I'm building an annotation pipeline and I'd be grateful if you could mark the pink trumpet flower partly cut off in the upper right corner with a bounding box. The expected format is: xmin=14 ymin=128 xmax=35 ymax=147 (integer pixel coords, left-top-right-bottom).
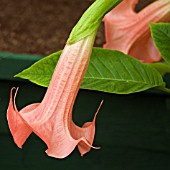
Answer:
xmin=104 ymin=0 xmax=170 ymax=62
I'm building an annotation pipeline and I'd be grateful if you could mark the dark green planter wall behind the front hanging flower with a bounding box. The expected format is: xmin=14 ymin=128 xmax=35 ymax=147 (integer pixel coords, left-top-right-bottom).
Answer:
xmin=0 ymin=54 xmax=170 ymax=170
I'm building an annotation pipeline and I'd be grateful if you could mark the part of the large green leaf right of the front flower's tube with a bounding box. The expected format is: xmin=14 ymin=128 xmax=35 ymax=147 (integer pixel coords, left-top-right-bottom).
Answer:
xmin=81 ymin=49 xmax=163 ymax=94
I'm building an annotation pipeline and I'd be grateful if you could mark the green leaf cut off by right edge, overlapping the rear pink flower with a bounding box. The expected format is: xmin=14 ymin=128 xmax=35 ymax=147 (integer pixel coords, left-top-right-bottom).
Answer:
xmin=150 ymin=23 xmax=170 ymax=64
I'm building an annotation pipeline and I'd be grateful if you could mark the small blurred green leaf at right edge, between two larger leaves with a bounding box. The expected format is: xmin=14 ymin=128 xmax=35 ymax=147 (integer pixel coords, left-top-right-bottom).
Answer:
xmin=149 ymin=62 xmax=170 ymax=76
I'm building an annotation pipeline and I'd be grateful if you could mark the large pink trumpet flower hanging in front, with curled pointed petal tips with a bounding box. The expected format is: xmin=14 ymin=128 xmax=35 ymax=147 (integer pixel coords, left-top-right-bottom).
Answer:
xmin=7 ymin=34 xmax=101 ymax=158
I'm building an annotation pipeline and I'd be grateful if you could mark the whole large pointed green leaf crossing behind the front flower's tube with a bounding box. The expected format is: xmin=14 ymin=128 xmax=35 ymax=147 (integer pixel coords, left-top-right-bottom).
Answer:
xmin=16 ymin=48 xmax=164 ymax=94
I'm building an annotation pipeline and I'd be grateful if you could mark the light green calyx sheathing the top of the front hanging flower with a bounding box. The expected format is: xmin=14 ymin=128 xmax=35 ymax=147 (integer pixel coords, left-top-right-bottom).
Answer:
xmin=67 ymin=0 xmax=122 ymax=44
